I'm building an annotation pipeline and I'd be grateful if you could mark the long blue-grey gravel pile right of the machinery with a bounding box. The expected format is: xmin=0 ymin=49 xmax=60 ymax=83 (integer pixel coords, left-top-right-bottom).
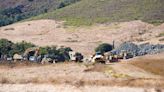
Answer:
xmin=112 ymin=42 xmax=164 ymax=56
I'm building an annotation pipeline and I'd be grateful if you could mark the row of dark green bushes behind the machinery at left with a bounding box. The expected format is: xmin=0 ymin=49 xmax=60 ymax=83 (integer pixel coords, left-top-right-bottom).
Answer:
xmin=0 ymin=39 xmax=72 ymax=62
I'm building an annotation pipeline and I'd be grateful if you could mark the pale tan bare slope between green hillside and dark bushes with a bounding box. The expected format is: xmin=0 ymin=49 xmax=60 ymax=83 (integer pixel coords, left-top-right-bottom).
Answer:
xmin=0 ymin=20 xmax=164 ymax=55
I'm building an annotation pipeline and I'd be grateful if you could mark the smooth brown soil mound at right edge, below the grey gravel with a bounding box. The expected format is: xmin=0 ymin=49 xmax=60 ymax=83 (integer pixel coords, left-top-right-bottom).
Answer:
xmin=131 ymin=54 xmax=164 ymax=77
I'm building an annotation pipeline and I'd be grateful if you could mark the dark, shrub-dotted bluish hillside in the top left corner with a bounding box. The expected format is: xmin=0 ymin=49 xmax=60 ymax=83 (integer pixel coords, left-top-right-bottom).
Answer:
xmin=0 ymin=0 xmax=79 ymax=26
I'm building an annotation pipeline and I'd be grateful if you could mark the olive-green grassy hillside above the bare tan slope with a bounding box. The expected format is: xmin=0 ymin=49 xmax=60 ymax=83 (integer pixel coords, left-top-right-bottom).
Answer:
xmin=32 ymin=0 xmax=164 ymax=26
